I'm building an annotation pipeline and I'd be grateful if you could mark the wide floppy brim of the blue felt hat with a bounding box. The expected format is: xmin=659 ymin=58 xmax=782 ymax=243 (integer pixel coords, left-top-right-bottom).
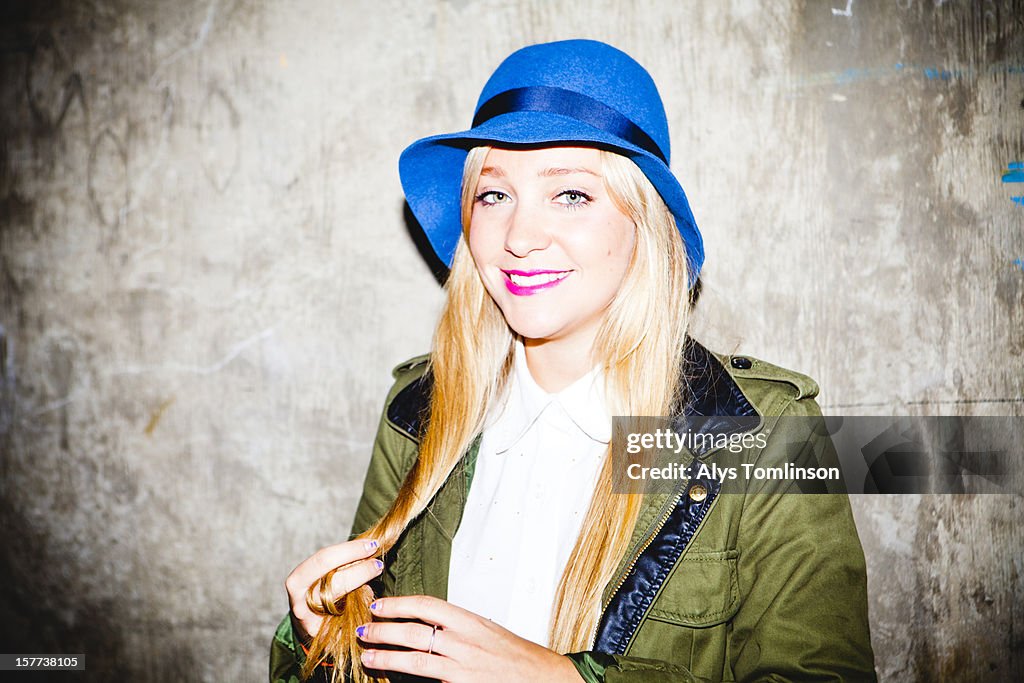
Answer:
xmin=398 ymin=112 xmax=703 ymax=286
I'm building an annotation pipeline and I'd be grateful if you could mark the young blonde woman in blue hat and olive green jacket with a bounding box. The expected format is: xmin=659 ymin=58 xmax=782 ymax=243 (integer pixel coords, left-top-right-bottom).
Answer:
xmin=270 ymin=40 xmax=874 ymax=683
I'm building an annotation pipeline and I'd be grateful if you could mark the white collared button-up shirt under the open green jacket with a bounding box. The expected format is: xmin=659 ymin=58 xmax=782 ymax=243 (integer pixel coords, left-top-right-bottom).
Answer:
xmin=447 ymin=342 xmax=611 ymax=645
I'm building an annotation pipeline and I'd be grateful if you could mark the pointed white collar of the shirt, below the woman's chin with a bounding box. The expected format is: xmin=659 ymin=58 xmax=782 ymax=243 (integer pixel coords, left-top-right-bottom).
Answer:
xmin=485 ymin=339 xmax=611 ymax=453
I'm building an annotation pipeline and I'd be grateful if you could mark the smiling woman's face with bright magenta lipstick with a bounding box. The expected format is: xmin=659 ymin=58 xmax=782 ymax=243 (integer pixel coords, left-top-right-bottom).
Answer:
xmin=469 ymin=147 xmax=635 ymax=352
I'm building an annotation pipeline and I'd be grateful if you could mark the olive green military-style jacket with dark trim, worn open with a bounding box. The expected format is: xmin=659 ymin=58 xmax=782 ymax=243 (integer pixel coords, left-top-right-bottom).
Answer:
xmin=270 ymin=342 xmax=876 ymax=683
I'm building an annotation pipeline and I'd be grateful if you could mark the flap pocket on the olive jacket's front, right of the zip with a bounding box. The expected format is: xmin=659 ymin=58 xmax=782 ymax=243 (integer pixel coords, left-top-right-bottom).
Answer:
xmin=648 ymin=550 xmax=739 ymax=628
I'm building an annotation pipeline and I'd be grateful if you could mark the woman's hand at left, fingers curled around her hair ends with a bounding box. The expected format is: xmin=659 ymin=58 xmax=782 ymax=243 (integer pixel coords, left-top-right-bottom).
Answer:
xmin=285 ymin=540 xmax=384 ymax=641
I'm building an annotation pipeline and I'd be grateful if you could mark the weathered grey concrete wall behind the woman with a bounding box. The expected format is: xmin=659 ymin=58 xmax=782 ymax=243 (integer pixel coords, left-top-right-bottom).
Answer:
xmin=0 ymin=0 xmax=1024 ymax=681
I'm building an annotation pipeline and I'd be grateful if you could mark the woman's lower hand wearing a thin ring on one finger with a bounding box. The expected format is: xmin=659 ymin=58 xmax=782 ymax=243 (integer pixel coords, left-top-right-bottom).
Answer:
xmin=355 ymin=595 xmax=581 ymax=683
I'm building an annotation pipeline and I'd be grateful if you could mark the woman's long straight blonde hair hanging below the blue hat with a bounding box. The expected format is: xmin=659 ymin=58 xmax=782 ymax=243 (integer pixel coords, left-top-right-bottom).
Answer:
xmin=302 ymin=146 xmax=690 ymax=683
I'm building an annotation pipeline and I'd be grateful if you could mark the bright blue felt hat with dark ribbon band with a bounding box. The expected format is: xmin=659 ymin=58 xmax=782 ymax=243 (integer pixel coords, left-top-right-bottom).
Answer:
xmin=398 ymin=40 xmax=703 ymax=285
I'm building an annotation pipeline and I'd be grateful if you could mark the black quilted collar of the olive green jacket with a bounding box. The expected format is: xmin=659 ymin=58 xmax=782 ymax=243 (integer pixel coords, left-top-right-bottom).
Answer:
xmin=387 ymin=338 xmax=759 ymax=441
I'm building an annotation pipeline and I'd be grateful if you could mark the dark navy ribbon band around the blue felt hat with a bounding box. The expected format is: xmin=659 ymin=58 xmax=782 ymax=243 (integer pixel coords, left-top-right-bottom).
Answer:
xmin=473 ymin=85 xmax=669 ymax=165
